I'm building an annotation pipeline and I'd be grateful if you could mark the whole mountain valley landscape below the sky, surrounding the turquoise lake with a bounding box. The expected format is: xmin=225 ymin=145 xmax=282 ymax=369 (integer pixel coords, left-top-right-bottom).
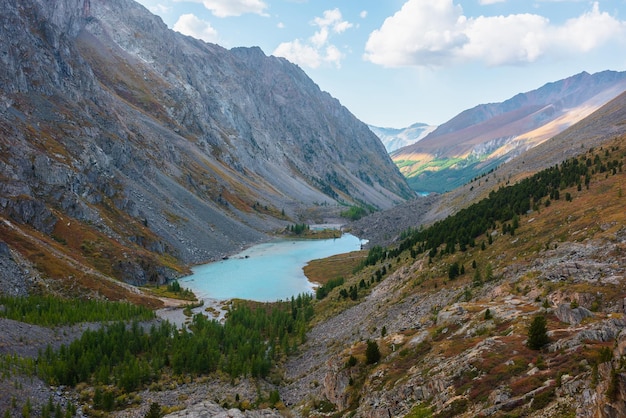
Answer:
xmin=0 ymin=0 xmax=626 ymax=418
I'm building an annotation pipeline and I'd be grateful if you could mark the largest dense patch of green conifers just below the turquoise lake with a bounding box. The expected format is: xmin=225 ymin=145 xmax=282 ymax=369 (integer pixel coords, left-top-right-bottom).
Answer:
xmin=37 ymin=295 xmax=313 ymax=392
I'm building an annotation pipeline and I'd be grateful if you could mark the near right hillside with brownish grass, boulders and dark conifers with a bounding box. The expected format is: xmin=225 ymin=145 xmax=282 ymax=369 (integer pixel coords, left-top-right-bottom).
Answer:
xmin=285 ymin=136 xmax=626 ymax=417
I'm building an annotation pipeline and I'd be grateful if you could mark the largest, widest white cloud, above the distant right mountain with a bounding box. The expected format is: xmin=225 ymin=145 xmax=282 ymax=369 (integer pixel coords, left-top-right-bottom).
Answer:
xmin=364 ymin=0 xmax=626 ymax=67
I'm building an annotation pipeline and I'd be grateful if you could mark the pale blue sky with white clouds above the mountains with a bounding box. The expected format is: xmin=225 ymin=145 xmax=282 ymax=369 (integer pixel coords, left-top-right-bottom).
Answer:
xmin=132 ymin=0 xmax=626 ymax=128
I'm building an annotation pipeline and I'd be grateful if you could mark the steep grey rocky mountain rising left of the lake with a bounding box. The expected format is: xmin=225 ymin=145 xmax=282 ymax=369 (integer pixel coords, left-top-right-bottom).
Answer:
xmin=0 ymin=0 xmax=414 ymax=297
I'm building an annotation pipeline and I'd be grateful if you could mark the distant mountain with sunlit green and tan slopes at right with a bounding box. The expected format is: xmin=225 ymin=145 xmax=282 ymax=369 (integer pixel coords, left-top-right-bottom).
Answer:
xmin=392 ymin=71 xmax=626 ymax=192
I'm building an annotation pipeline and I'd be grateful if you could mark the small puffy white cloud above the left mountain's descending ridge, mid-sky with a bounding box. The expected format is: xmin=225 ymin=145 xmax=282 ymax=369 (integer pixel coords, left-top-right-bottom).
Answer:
xmin=272 ymin=9 xmax=353 ymax=68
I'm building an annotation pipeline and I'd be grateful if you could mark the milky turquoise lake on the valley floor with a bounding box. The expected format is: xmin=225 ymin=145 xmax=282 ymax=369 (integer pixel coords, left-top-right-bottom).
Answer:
xmin=179 ymin=234 xmax=361 ymax=302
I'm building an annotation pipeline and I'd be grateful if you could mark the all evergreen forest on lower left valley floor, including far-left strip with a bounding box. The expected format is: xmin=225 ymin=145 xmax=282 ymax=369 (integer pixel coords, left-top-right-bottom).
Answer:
xmin=1 ymin=295 xmax=313 ymax=411
